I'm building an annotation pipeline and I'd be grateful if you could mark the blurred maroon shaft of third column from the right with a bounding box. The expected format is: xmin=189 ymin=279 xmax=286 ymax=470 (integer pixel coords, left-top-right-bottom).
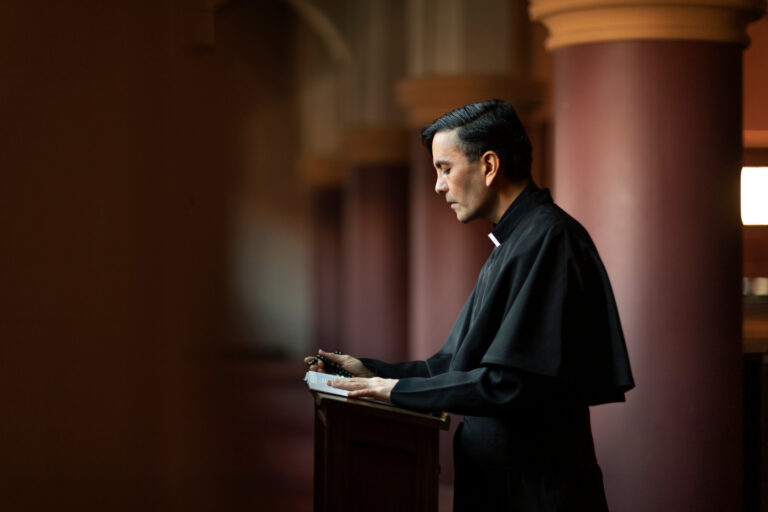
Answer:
xmin=344 ymin=164 xmax=408 ymax=362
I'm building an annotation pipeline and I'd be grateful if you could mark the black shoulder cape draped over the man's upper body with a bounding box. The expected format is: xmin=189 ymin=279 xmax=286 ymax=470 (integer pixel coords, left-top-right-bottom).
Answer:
xmin=427 ymin=183 xmax=634 ymax=405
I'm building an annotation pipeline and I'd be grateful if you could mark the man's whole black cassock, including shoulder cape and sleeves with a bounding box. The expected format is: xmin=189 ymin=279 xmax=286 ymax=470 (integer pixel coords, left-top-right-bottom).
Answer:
xmin=362 ymin=183 xmax=634 ymax=512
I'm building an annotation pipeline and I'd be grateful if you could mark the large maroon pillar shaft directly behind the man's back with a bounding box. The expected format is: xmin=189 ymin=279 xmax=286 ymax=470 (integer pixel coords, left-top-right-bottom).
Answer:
xmin=554 ymin=41 xmax=742 ymax=512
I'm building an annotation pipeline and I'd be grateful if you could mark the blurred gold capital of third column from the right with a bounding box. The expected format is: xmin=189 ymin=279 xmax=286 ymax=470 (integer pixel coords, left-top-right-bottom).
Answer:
xmin=341 ymin=127 xmax=410 ymax=165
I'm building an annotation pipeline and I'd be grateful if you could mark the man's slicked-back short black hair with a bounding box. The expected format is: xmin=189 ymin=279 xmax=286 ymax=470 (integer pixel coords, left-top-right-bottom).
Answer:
xmin=421 ymin=100 xmax=531 ymax=181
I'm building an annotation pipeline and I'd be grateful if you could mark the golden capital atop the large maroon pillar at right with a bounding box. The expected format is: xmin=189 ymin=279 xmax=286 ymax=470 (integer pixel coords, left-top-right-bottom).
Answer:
xmin=529 ymin=0 xmax=766 ymax=50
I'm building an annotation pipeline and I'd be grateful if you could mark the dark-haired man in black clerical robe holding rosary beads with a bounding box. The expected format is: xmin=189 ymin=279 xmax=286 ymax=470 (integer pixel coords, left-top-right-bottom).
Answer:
xmin=305 ymin=100 xmax=634 ymax=512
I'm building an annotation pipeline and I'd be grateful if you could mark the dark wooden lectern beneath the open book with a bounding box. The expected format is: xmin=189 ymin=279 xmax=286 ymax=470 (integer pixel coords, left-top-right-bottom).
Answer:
xmin=312 ymin=392 xmax=450 ymax=512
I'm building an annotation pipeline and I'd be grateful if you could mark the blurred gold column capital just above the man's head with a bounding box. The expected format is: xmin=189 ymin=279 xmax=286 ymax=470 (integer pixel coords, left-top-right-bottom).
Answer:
xmin=395 ymin=75 xmax=545 ymax=127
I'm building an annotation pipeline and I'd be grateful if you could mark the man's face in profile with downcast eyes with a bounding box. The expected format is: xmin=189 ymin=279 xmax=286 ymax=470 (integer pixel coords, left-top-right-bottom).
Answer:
xmin=432 ymin=130 xmax=491 ymax=223
